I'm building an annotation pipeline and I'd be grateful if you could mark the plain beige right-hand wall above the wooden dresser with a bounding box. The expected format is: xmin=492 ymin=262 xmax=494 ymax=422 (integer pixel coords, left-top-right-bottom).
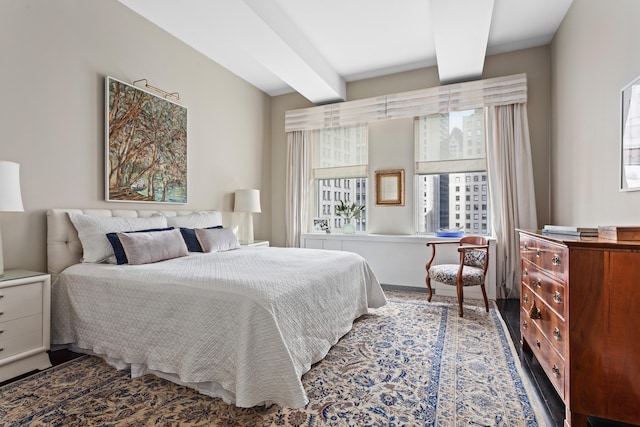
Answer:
xmin=551 ymin=0 xmax=640 ymax=227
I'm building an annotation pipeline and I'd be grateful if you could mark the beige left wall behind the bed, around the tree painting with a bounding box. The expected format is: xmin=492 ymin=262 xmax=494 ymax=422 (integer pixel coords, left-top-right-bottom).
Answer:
xmin=0 ymin=0 xmax=271 ymax=270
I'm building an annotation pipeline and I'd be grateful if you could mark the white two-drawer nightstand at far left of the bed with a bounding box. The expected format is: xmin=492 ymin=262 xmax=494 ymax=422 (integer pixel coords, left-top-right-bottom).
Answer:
xmin=0 ymin=270 xmax=51 ymax=381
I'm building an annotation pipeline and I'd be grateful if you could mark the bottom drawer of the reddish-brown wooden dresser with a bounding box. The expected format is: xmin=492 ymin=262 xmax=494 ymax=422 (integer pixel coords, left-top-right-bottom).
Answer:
xmin=520 ymin=308 xmax=565 ymax=400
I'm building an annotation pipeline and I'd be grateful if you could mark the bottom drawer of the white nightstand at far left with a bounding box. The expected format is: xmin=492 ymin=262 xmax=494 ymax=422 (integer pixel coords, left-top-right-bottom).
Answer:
xmin=0 ymin=314 xmax=43 ymax=365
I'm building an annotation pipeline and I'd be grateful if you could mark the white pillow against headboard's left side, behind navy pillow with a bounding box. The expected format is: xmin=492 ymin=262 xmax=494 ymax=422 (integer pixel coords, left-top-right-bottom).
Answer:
xmin=69 ymin=212 xmax=167 ymax=262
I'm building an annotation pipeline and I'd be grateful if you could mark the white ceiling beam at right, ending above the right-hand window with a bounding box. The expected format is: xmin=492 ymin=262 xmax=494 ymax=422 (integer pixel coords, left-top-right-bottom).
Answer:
xmin=431 ymin=0 xmax=494 ymax=84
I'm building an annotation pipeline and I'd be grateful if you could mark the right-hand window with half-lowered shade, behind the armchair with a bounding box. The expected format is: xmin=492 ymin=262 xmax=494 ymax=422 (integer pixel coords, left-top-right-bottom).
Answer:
xmin=415 ymin=108 xmax=490 ymax=234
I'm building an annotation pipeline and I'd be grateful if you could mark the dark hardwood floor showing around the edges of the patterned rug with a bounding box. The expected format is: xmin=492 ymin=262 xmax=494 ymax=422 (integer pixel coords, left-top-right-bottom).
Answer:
xmin=0 ymin=285 xmax=633 ymax=427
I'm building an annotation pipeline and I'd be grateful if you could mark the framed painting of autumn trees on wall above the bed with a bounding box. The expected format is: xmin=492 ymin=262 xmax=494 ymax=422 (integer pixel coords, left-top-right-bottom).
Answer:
xmin=105 ymin=77 xmax=187 ymax=203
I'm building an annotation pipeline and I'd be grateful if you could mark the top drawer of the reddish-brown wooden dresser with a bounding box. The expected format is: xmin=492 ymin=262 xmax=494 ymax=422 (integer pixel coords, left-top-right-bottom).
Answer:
xmin=520 ymin=235 xmax=569 ymax=282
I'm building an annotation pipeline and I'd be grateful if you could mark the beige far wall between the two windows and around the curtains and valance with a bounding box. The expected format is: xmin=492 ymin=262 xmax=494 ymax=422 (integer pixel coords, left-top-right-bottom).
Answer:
xmin=271 ymin=46 xmax=550 ymax=245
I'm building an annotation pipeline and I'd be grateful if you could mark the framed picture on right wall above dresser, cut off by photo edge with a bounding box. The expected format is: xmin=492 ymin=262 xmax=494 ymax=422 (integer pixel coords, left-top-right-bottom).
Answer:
xmin=620 ymin=77 xmax=640 ymax=191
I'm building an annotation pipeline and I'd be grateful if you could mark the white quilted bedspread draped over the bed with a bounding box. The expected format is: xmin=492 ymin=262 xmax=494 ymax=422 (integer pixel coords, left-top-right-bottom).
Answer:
xmin=52 ymin=247 xmax=386 ymax=407
